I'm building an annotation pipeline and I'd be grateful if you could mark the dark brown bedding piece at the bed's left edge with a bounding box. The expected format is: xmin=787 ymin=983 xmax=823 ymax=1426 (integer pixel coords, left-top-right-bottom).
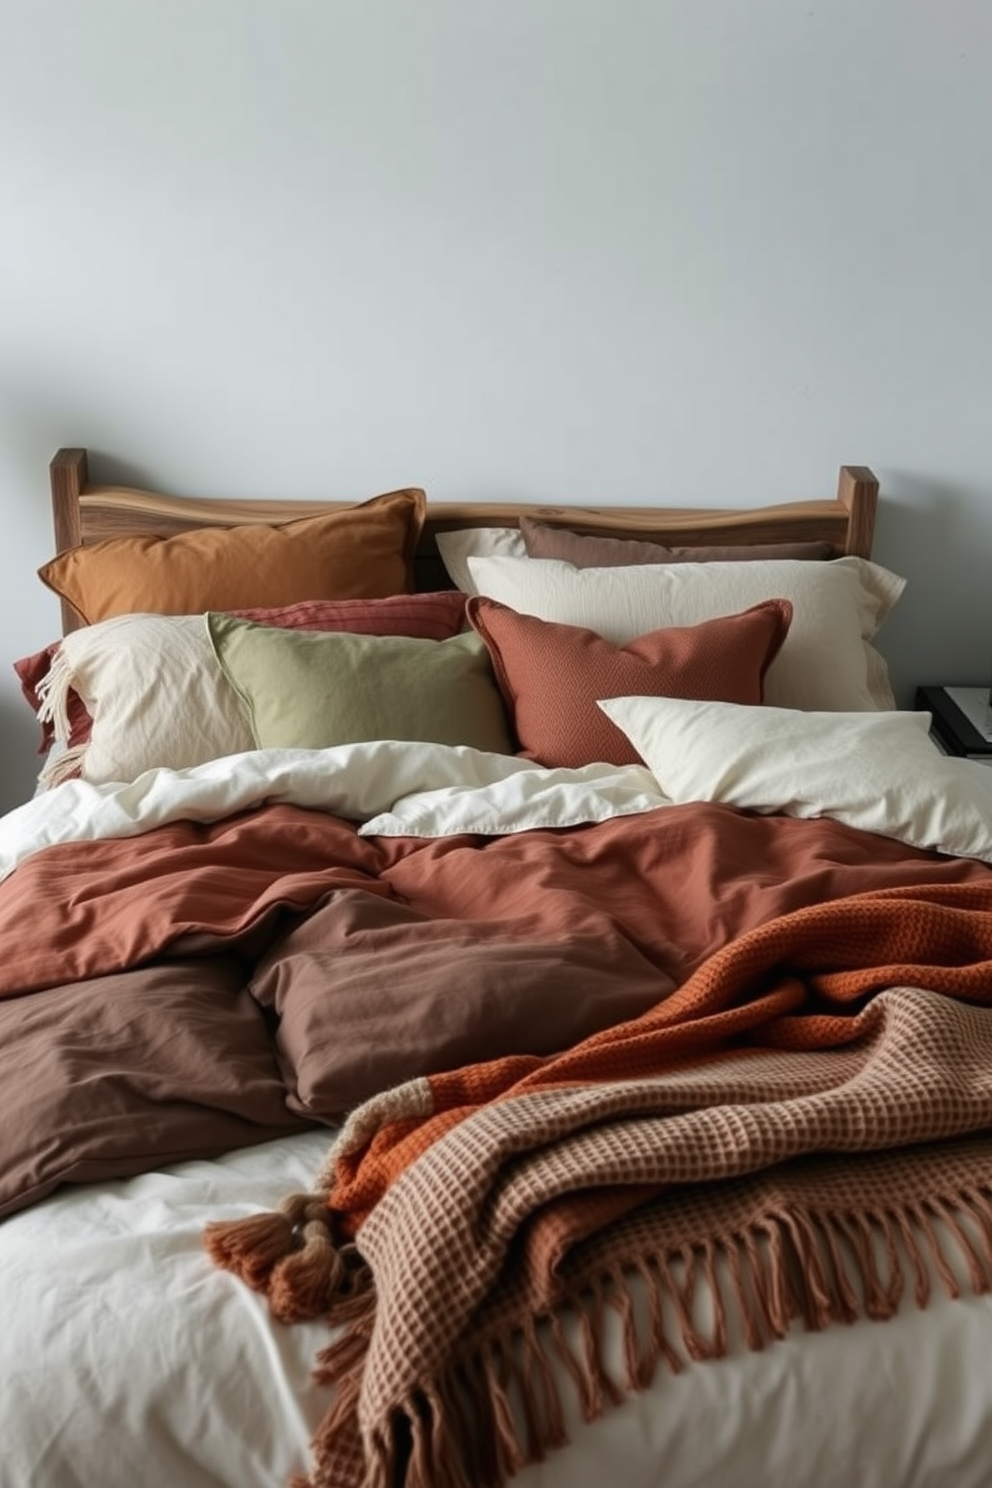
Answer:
xmin=0 ymin=955 xmax=310 ymax=1217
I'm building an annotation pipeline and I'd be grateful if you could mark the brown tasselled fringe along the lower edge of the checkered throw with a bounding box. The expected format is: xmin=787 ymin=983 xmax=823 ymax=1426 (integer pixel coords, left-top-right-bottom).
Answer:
xmin=294 ymin=1189 xmax=992 ymax=1488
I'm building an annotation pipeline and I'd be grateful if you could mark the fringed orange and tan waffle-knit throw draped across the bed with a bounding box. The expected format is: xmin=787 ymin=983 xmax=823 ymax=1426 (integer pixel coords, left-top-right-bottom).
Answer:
xmin=207 ymin=881 xmax=992 ymax=1488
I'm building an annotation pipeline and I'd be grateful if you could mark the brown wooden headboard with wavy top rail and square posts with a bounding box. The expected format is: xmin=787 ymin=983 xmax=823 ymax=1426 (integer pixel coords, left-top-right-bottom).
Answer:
xmin=51 ymin=449 xmax=879 ymax=631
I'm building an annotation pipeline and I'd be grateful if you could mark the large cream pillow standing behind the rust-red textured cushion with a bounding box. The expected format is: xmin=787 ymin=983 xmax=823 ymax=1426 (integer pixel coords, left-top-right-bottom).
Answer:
xmin=468 ymin=558 xmax=906 ymax=711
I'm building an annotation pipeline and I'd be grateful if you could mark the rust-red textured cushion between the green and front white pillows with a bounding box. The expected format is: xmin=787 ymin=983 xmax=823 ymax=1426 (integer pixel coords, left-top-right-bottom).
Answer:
xmin=466 ymin=595 xmax=793 ymax=769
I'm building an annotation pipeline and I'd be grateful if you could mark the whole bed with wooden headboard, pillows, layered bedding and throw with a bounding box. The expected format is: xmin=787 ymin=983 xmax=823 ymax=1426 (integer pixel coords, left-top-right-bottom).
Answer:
xmin=0 ymin=449 xmax=992 ymax=1488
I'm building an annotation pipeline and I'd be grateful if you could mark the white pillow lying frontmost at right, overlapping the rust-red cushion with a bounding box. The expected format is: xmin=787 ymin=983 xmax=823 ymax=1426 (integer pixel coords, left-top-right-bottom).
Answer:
xmin=599 ymin=698 xmax=992 ymax=863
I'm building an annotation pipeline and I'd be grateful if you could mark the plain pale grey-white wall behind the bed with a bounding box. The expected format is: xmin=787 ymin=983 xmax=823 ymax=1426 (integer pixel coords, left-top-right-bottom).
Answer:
xmin=0 ymin=0 xmax=992 ymax=805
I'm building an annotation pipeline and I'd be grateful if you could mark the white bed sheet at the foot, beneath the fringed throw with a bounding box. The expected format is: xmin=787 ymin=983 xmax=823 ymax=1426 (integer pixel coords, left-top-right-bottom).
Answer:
xmin=0 ymin=1131 xmax=992 ymax=1488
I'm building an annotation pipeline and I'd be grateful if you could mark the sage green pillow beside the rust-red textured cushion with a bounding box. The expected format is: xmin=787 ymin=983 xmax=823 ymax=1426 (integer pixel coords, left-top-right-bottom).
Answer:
xmin=207 ymin=612 xmax=513 ymax=754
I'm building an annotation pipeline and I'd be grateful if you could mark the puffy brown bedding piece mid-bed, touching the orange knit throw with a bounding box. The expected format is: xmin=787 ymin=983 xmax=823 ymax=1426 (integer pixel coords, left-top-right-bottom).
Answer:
xmin=250 ymin=888 xmax=674 ymax=1120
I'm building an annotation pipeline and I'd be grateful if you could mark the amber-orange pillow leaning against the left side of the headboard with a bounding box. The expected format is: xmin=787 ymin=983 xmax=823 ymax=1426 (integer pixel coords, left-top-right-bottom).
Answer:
xmin=39 ymin=490 xmax=427 ymax=625
